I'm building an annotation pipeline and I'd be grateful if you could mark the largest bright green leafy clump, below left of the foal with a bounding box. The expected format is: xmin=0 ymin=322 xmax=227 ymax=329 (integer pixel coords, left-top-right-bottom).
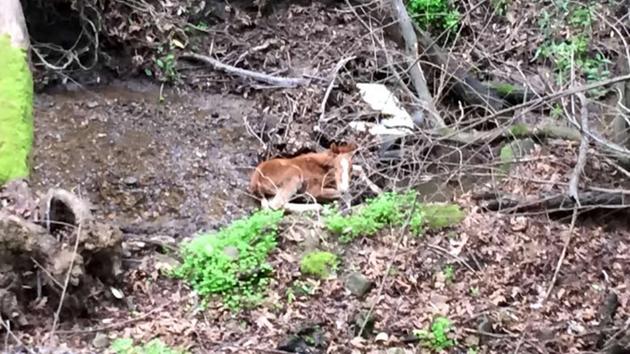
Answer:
xmin=173 ymin=210 xmax=283 ymax=309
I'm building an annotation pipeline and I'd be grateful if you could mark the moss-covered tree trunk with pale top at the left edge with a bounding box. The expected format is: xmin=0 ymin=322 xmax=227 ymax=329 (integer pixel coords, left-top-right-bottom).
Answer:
xmin=0 ymin=0 xmax=33 ymax=185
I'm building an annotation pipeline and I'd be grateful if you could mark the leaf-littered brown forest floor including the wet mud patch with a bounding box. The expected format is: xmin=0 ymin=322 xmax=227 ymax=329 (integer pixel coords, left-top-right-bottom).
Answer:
xmin=2 ymin=0 xmax=630 ymax=353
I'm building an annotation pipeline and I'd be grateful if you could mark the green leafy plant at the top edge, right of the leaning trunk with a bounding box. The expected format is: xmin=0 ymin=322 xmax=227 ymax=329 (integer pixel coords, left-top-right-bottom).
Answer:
xmin=407 ymin=0 xmax=460 ymax=30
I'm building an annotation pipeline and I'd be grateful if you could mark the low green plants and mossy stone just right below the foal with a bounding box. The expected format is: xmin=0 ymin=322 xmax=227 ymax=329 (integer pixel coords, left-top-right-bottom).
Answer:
xmin=325 ymin=191 xmax=464 ymax=242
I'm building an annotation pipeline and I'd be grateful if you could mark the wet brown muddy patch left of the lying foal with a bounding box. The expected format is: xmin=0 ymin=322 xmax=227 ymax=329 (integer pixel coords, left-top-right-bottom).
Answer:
xmin=32 ymin=81 xmax=260 ymax=236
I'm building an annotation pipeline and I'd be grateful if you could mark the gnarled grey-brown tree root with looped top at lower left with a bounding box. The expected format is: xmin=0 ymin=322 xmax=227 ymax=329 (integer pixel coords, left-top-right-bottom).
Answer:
xmin=0 ymin=184 xmax=122 ymax=326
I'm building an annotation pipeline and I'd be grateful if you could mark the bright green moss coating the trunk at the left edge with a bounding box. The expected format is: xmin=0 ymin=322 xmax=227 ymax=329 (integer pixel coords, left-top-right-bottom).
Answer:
xmin=0 ymin=35 xmax=33 ymax=184
